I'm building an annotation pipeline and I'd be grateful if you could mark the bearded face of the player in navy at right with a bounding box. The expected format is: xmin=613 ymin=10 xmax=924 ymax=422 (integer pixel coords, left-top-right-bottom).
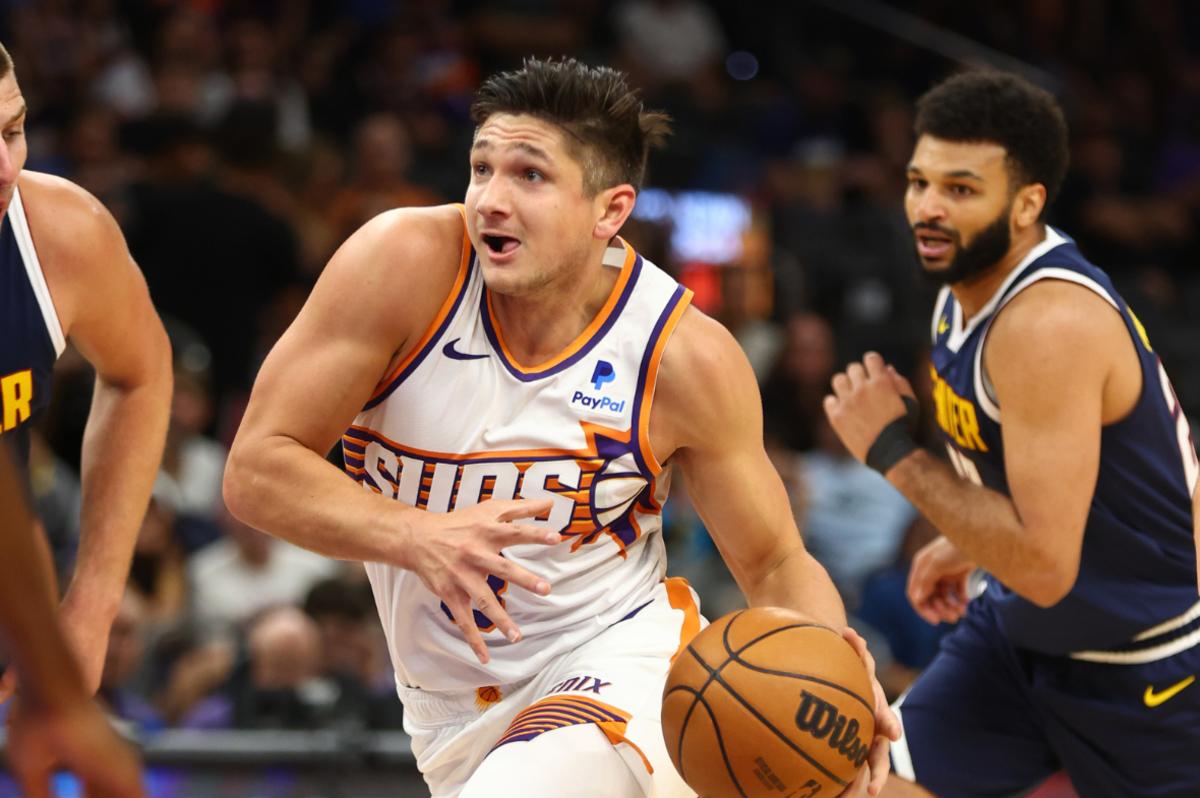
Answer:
xmin=905 ymin=136 xmax=1013 ymax=283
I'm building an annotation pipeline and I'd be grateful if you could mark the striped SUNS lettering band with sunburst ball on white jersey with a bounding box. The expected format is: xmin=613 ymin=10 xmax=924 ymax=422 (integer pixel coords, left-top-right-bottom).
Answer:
xmin=342 ymin=421 xmax=662 ymax=557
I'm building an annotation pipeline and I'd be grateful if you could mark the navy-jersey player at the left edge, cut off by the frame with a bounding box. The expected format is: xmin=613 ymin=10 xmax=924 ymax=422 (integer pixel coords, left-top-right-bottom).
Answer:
xmin=0 ymin=46 xmax=172 ymax=697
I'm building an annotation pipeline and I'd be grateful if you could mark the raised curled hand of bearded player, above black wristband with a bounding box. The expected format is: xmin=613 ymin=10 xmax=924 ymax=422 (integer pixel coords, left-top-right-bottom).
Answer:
xmin=824 ymin=352 xmax=912 ymax=462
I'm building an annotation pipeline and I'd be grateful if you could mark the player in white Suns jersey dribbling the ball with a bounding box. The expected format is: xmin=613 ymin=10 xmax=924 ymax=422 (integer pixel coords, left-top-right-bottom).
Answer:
xmin=224 ymin=60 xmax=896 ymax=798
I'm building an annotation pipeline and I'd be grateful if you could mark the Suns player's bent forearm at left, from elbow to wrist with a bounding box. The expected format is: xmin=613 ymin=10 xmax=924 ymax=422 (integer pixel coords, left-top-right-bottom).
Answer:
xmin=224 ymin=436 xmax=421 ymax=568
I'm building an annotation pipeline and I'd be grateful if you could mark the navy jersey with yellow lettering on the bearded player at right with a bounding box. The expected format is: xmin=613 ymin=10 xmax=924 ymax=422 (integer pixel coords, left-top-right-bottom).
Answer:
xmin=932 ymin=227 xmax=1200 ymax=662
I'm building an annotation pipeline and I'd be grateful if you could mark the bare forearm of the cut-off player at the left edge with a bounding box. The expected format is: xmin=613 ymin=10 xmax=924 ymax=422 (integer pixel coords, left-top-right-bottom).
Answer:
xmin=65 ymin=369 xmax=172 ymax=620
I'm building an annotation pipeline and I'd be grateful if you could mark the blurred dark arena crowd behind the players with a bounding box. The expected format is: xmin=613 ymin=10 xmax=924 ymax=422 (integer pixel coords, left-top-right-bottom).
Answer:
xmin=7 ymin=0 xmax=1200 ymax=731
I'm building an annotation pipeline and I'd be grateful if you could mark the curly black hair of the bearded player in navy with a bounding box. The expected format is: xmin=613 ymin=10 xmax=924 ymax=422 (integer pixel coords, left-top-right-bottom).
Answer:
xmin=913 ymin=71 xmax=1070 ymax=215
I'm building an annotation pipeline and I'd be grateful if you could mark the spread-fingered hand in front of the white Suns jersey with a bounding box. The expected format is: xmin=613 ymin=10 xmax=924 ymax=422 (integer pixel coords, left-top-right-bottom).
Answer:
xmin=403 ymin=499 xmax=563 ymax=665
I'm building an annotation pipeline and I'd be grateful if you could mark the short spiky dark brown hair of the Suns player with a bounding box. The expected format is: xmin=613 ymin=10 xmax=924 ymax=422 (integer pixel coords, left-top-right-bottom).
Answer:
xmin=470 ymin=59 xmax=671 ymax=196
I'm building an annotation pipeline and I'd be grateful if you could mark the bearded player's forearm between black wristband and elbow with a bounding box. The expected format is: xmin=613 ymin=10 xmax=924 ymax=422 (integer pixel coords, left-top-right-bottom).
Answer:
xmin=887 ymin=449 xmax=1063 ymax=602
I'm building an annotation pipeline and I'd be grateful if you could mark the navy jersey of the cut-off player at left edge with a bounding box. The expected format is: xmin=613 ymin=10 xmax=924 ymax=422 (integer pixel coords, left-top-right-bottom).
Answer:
xmin=0 ymin=191 xmax=65 ymax=460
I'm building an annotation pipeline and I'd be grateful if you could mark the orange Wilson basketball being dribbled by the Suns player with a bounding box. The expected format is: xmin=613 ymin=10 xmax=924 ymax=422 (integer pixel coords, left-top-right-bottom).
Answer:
xmin=662 ymin=607 xmax=875 ymax=798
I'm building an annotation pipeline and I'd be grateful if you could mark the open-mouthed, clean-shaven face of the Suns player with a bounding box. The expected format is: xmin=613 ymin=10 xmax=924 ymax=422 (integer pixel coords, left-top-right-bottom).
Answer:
xmin=466 ymin=114 xmax=596 ymax=295
